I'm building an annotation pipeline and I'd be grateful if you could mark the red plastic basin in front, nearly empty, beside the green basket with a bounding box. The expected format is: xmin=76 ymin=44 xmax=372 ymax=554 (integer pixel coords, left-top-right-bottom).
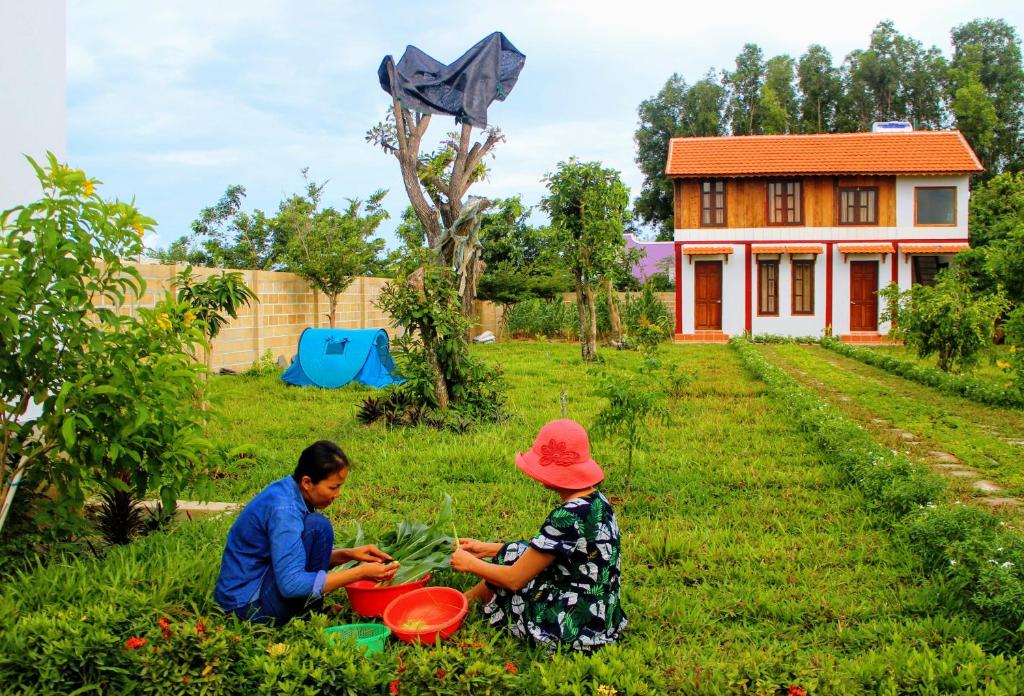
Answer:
xmin=384 ymin=588 xmax=469 ymax=643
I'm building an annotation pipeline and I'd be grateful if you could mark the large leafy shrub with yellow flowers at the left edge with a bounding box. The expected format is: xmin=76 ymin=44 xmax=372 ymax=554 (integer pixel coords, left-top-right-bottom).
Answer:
xmin=0 ymin=155 xmax=218 ymax=536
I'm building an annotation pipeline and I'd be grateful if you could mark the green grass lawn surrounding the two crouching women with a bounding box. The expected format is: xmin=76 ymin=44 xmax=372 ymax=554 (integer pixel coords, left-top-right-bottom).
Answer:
xmin=0 ymin=343 xmax=1024 ymax=694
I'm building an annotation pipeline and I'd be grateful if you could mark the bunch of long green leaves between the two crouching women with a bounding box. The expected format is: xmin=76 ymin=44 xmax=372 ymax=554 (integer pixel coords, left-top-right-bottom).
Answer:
xmin=377 ymin=494 xmax=457 ymax=584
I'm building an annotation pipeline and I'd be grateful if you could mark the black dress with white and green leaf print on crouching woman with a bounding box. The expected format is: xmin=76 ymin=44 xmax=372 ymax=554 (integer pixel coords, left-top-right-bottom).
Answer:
xmin=483 ymin=491 xmax=626 ymax=652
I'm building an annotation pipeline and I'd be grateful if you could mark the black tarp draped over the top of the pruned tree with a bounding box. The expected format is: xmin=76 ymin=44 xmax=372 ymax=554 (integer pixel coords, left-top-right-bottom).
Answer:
xmin=377 ymin=32 xmax=526 ymax=128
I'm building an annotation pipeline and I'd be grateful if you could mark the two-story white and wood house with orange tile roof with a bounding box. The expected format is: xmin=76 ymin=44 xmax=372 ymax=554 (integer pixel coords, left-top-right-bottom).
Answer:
xmin=666 ymin=130 xmax=983 ymax=341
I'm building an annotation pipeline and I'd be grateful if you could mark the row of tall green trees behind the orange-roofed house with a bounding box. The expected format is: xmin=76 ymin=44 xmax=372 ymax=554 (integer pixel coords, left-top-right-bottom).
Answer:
xmin=634 ymin=18 xmax=1024 ymax=240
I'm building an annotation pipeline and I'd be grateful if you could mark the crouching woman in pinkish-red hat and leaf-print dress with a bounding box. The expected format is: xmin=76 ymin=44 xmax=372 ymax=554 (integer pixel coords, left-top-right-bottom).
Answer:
xmin=452 ymin=420 xmax=626 ymax=651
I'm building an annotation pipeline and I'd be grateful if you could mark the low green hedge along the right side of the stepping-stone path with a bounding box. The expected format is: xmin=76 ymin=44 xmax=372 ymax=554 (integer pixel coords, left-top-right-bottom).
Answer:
xmin=821 ymin=338 xmax=1024 ymax=408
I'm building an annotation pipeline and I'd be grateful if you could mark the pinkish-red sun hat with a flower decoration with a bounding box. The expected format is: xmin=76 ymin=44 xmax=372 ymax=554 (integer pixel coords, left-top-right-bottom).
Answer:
xmin=515 ymin=419 xmax=604 ymax=490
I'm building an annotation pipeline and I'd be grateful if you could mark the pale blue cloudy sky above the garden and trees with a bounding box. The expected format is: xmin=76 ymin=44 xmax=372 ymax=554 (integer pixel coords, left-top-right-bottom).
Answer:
xmin=67 ymin=0 xmax=1024 ymax=247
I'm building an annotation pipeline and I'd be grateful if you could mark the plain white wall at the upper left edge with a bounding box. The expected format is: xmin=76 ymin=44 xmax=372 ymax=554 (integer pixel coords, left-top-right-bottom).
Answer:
xmin=0 ymin=0 xmax=68 ymax=211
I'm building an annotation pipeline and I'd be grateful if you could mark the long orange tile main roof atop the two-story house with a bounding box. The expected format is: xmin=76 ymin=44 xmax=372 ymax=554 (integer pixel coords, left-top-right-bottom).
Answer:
xmin=665 ymin=131 xmax=984 ymax=178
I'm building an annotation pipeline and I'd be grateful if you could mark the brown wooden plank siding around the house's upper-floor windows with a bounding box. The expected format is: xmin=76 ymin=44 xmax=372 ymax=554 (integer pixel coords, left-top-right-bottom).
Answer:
xmin=673 ymin=176 xmax=896 ymax=230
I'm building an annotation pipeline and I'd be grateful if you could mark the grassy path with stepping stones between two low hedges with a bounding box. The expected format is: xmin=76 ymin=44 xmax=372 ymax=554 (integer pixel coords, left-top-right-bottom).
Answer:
xmin=761 ymin=345 xmax=1024 ymax=514
